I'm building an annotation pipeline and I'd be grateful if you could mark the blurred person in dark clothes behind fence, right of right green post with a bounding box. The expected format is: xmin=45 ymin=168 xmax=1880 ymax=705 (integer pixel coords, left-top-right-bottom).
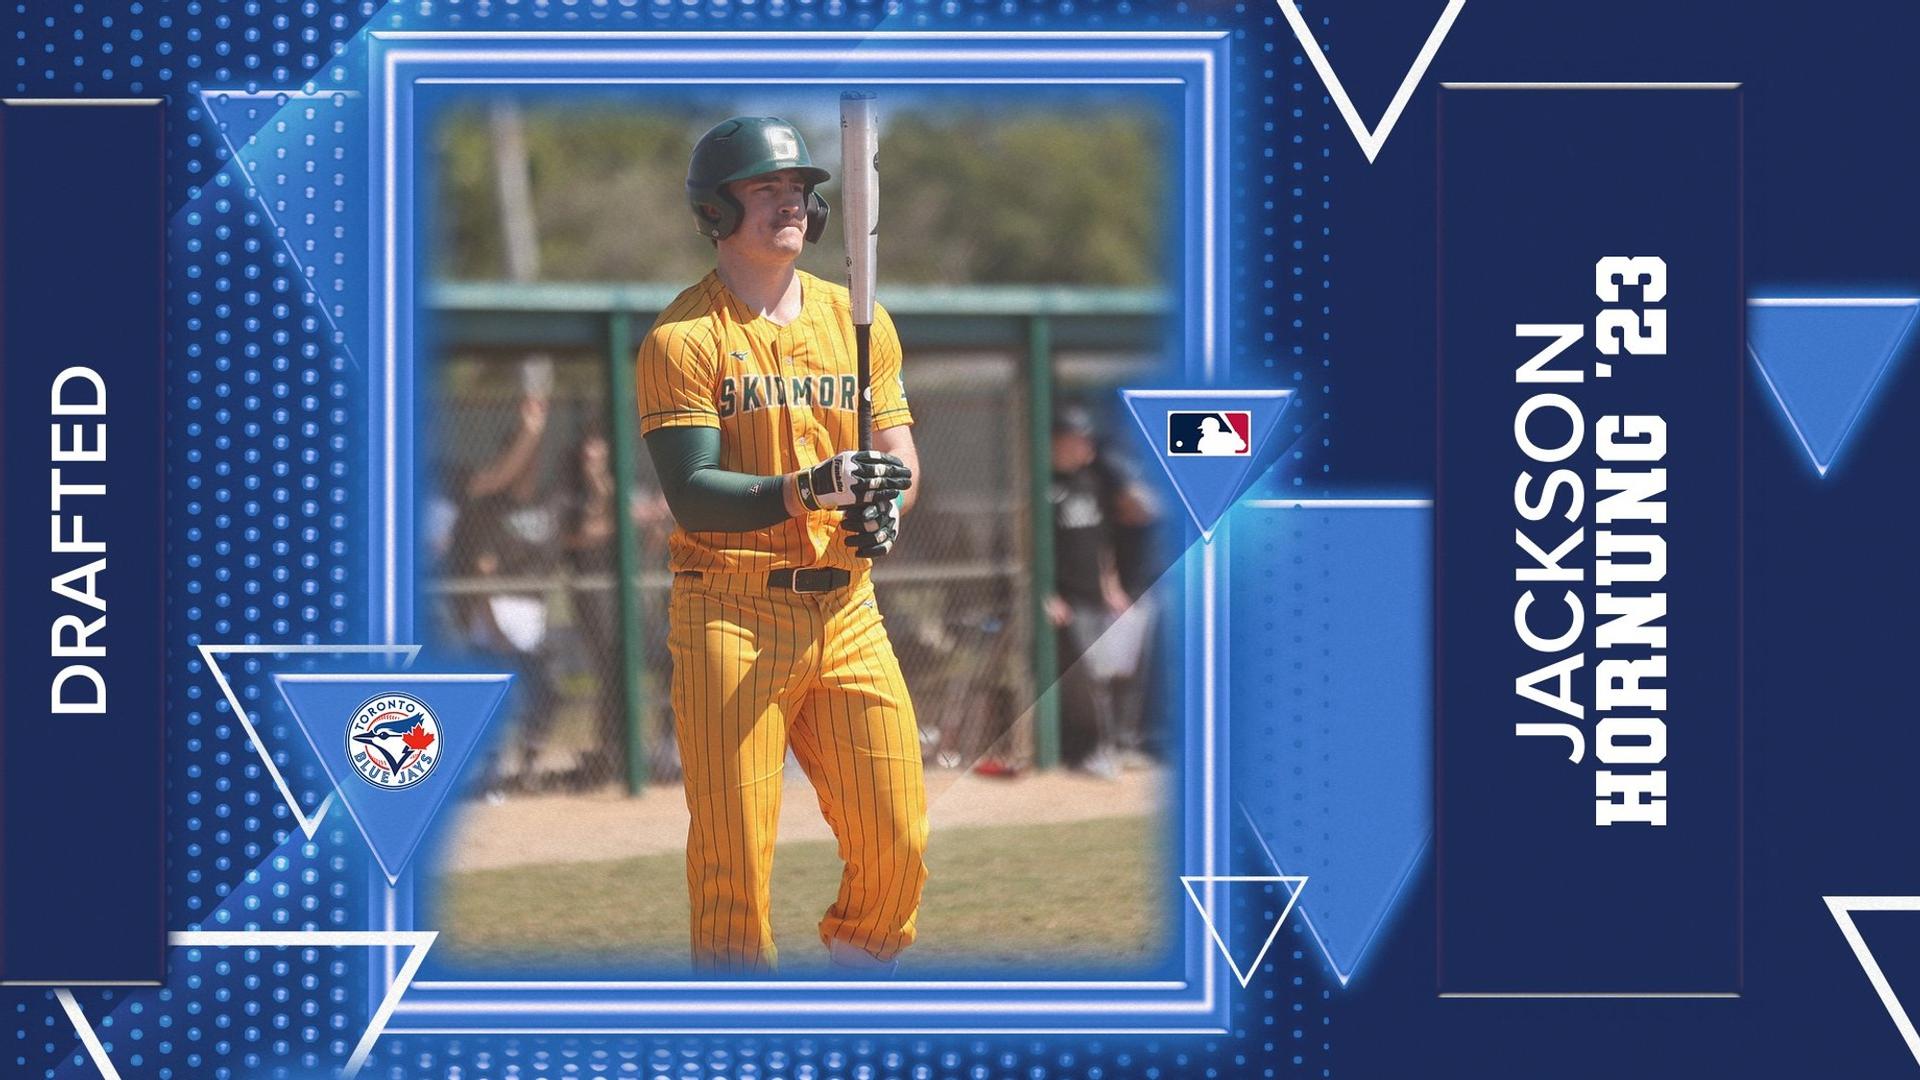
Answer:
xmin=1046 ymin=405 xmax=1150 ymax=778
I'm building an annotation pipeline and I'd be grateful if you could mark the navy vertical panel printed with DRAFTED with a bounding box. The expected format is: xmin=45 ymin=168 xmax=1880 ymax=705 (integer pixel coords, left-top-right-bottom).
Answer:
xmin=0 ymin=102 xmax=165 ymax=982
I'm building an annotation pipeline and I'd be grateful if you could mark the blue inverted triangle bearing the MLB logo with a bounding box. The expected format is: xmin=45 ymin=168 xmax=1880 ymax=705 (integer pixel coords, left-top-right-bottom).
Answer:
xmin=1119 ymin=390 xmax=1292 ymax=540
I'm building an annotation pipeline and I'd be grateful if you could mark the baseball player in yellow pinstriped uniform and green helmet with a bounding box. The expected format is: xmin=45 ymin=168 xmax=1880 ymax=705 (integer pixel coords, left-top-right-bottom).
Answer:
xmin=637 ymin=117 xmax=927 ymax=972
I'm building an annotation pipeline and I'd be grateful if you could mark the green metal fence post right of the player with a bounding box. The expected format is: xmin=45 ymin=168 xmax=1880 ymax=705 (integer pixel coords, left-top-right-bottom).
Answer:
xmin=1027 ymin=315 xmax=1060 ymax=769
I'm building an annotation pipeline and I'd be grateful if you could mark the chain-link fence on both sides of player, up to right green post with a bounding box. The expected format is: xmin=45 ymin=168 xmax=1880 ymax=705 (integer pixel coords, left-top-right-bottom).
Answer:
xmin=426 ymin=336 xmax=1059 ymax=792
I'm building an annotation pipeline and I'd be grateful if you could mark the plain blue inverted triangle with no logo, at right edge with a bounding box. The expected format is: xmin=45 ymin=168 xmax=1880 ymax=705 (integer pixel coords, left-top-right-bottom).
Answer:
xmin=1747 ymin=298 xmax=1920 ymax=477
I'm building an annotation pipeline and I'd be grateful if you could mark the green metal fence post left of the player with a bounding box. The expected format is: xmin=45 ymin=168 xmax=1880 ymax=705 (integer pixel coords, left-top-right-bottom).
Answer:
xmin=607 ymin=309 xmax=647 ymax=796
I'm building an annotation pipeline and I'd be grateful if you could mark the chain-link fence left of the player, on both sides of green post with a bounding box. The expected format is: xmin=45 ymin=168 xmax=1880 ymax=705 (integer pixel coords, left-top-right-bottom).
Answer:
xmin=426 ymin=352 xmax=678 ymax=790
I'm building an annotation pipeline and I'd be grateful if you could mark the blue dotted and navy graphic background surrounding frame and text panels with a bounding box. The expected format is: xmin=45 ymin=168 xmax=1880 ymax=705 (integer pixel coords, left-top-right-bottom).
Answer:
xmin=0 ymin=0 xmax=1920 ymax=1078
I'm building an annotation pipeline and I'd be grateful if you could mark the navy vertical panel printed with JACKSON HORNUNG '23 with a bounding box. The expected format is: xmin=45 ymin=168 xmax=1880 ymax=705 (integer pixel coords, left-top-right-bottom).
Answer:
xmin=1434 ymin=88 xmax=1745 ymax=994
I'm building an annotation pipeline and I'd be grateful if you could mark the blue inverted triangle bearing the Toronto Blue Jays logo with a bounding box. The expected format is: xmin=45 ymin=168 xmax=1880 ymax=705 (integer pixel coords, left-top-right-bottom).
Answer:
xmin=273 ymin=673 xmax=513 ymax=882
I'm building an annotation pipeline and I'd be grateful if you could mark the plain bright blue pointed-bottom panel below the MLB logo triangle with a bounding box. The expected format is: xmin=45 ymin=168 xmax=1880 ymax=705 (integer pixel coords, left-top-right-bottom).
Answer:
xmin=1229 ymin=500 xmax=1432 ymax=984
